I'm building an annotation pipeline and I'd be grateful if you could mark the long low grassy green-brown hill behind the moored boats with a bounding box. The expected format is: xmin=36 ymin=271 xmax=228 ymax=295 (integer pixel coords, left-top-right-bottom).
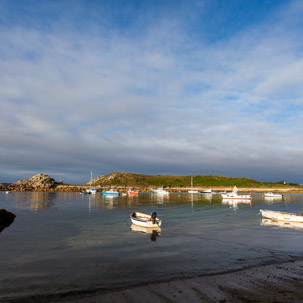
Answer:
xmin=93 ymin=173 xmax=299 ymax=188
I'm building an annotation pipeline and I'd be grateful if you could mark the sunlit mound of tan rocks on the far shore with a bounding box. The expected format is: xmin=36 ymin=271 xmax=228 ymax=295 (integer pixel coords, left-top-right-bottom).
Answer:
xmin=10 ymin=174 xmax=57 ymax=190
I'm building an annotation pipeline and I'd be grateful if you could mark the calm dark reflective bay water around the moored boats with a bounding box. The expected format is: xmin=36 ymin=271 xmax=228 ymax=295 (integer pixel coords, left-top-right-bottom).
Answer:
xmin=0 ymin=192 xmax=303 ymax=299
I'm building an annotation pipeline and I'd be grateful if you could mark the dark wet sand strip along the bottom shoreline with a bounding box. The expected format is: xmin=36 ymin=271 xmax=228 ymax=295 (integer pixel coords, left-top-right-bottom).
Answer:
xmin=7 ymin=261 xmax=303 ymax=303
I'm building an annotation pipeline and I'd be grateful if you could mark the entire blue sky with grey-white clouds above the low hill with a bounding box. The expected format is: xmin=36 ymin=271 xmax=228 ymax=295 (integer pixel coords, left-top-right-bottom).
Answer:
xmin=0 ymin=0 xmax=303 ymax=184
